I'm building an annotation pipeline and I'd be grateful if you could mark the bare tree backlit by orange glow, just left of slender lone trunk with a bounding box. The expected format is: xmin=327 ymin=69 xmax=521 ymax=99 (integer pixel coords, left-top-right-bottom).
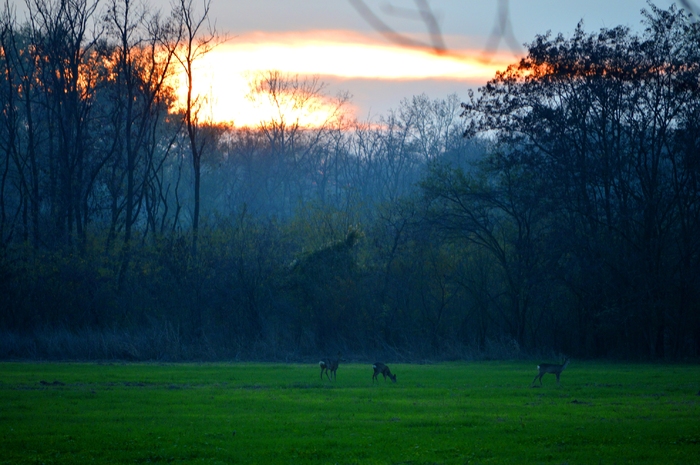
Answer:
xmin=104 ymin=0 xmax=179 ymax=286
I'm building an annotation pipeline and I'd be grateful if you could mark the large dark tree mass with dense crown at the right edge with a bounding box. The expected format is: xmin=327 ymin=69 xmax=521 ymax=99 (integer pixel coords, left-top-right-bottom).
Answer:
xmin=448 ymin=5 xmax=700 ymax=357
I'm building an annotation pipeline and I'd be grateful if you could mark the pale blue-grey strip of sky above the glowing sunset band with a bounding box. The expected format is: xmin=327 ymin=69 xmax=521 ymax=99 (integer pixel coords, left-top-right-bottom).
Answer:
xmin=213 ymin=0 xmax=656 ymax=38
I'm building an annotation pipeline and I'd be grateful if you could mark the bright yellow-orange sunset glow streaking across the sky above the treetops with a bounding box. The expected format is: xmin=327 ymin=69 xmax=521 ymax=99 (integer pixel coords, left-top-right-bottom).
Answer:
xmin=170 ymin=31 xmax=512 ymax=127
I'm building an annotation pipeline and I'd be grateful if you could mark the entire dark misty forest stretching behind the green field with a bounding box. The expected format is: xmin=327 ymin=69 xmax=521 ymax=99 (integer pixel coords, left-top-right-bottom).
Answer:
xmin=0 ymin=0 xmax=700 ymax=361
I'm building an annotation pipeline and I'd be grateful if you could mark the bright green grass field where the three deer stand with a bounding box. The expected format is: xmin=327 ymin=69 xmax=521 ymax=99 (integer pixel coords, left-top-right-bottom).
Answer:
xmin=0 ymin=361 xmax=700 ymax=465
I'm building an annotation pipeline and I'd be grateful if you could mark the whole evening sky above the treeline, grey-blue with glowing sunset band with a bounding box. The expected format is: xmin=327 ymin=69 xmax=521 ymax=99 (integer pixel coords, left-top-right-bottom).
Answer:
xmin=19 ymin=0 xmax=700 ymax=126
